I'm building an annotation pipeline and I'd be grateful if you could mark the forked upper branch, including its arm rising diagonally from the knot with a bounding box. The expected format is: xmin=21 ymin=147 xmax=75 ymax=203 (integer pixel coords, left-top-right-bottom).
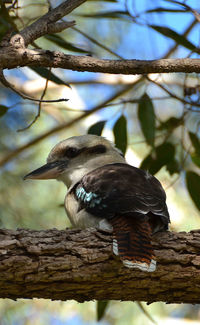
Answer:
xmin=0 ymin=0 xmax=200 ymax=75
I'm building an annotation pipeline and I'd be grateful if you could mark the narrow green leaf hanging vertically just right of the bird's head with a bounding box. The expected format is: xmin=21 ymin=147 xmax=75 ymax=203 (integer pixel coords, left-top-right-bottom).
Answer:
xmin=113 ymin=115 xmax=127 ymax=155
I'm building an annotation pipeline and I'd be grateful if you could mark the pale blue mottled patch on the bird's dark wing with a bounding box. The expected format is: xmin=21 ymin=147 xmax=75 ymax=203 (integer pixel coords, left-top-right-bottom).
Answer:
xmin=76 ymin=187 xmax=106 ymax=208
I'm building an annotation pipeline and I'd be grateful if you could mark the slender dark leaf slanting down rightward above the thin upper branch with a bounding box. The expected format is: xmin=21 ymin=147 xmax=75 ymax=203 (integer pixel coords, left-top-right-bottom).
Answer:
xmin=149 ymin=25 xmax=199 ymax=53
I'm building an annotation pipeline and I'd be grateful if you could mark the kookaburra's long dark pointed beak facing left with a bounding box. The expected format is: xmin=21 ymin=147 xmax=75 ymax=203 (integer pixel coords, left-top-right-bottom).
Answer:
xmin=24 ymin=160 xmax=68 ymax=180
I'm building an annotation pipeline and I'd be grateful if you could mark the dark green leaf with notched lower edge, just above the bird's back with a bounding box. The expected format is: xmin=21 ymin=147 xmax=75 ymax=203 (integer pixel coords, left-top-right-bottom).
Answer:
xmin=140 ymin=142 xmax=176 ymax=175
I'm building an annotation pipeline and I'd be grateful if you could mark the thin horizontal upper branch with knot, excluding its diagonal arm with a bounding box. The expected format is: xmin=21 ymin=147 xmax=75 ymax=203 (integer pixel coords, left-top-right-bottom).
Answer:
xmin=0 ymin=46 xmax=200 ymax=75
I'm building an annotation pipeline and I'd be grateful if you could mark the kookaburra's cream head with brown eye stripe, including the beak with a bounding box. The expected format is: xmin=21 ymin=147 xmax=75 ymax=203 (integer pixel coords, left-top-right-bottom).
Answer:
xmin=24 ymin=134 xmax=125 ymax=187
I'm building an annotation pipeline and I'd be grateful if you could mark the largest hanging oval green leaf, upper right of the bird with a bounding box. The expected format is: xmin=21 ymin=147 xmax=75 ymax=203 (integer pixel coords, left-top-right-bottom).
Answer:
xmin=138 ymin=94 xmax=155 ymax=146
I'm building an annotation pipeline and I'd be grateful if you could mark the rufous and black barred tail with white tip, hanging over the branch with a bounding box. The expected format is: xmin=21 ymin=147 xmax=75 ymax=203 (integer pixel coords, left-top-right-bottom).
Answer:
xmin=111 ymin=217 xmax=156 ymax=272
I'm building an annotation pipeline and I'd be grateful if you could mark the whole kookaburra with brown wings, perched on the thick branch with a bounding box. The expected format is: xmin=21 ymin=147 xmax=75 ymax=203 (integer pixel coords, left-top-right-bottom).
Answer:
xmin=24 ymin=134 xmax=170 ymax=272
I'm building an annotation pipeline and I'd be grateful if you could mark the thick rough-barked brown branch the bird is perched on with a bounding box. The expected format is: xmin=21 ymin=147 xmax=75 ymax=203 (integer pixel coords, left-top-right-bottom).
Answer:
xmin=0 ymin=228 xmax=200 ymax=303
